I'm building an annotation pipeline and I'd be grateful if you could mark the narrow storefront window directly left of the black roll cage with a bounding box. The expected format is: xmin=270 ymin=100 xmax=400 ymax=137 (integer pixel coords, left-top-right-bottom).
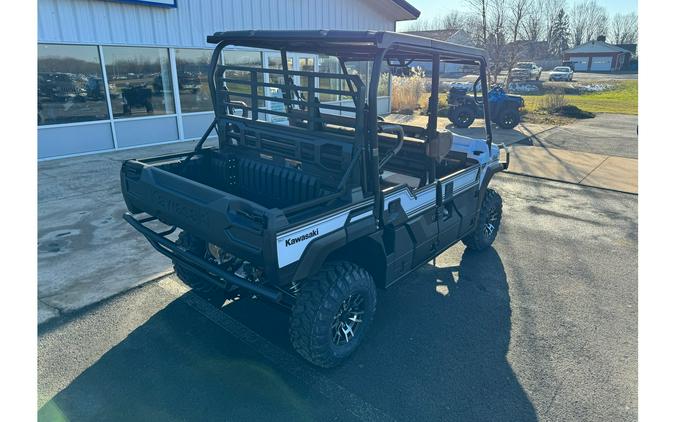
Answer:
xmin=176 ymin=48 xmax=213 ymax=113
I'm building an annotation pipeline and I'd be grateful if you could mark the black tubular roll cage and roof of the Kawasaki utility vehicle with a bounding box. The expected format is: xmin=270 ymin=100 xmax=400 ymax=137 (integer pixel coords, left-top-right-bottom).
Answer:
xmin=199 ymin=30 xmax=492 ymax=226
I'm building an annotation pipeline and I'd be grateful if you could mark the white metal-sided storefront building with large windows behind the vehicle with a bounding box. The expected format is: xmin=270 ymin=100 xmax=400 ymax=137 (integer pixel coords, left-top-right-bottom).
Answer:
xmin=38 ymin=0 xmax=419 ymax=159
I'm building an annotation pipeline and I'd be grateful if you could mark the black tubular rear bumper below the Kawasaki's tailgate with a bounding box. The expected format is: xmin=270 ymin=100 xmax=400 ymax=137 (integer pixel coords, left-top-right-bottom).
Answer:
xmin=124 ymin=213 xmax=282 ymax=302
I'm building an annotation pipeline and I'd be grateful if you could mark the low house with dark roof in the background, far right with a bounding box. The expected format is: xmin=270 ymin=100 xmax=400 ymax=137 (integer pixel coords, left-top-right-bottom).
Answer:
xmin=563 ymin=36 xmax=637 ymax=72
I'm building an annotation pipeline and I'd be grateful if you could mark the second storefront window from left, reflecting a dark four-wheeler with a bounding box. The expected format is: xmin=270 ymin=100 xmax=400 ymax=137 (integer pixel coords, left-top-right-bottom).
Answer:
xmin=103 ymin=47 xmax=175 ymax=118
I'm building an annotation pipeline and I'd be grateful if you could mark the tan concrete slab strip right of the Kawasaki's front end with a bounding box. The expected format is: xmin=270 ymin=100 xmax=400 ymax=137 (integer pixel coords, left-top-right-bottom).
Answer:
xmin=508 ymin=145 xmax=638 ymax=194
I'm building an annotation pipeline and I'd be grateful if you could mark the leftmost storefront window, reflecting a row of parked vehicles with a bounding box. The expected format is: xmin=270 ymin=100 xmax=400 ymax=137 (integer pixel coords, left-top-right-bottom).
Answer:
xmin=38 ymin=44 xmax=109 ymax=125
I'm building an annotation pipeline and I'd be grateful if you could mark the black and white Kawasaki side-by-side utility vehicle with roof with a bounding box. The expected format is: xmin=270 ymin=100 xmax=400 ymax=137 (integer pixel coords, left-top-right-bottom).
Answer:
xmin=121 ymin=31 xmax=508 ymax=367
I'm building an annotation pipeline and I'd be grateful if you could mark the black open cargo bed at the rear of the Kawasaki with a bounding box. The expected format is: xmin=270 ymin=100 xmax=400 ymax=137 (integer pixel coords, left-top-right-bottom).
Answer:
xmin=121 ymin=149 xmax=352 ymax=274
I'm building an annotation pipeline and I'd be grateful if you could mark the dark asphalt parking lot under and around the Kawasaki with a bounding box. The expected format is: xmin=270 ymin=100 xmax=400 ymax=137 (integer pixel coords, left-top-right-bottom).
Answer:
xmin=38 ymin=174 xmax=638 ymax=421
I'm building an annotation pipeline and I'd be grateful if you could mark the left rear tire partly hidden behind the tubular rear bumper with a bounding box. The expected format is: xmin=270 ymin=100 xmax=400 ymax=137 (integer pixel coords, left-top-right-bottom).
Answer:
xmin=173 ymin=232 xmax=231 ymax=306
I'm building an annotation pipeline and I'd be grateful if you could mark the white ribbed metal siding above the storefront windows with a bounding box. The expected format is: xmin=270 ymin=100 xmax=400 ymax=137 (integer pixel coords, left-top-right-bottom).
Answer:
xmin=38 ymin=0 xmax=396 ymax=47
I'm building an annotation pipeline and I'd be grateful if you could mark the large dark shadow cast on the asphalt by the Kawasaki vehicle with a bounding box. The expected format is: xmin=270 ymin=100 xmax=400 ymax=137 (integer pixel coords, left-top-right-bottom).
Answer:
xmin=38 ymin=249 xmax=536 ymax=421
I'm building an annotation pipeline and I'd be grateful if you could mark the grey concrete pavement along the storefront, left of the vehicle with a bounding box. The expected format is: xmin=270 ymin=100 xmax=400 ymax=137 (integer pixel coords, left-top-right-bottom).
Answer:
xmin=38 ymin=138 xmax=218 ymax=324
